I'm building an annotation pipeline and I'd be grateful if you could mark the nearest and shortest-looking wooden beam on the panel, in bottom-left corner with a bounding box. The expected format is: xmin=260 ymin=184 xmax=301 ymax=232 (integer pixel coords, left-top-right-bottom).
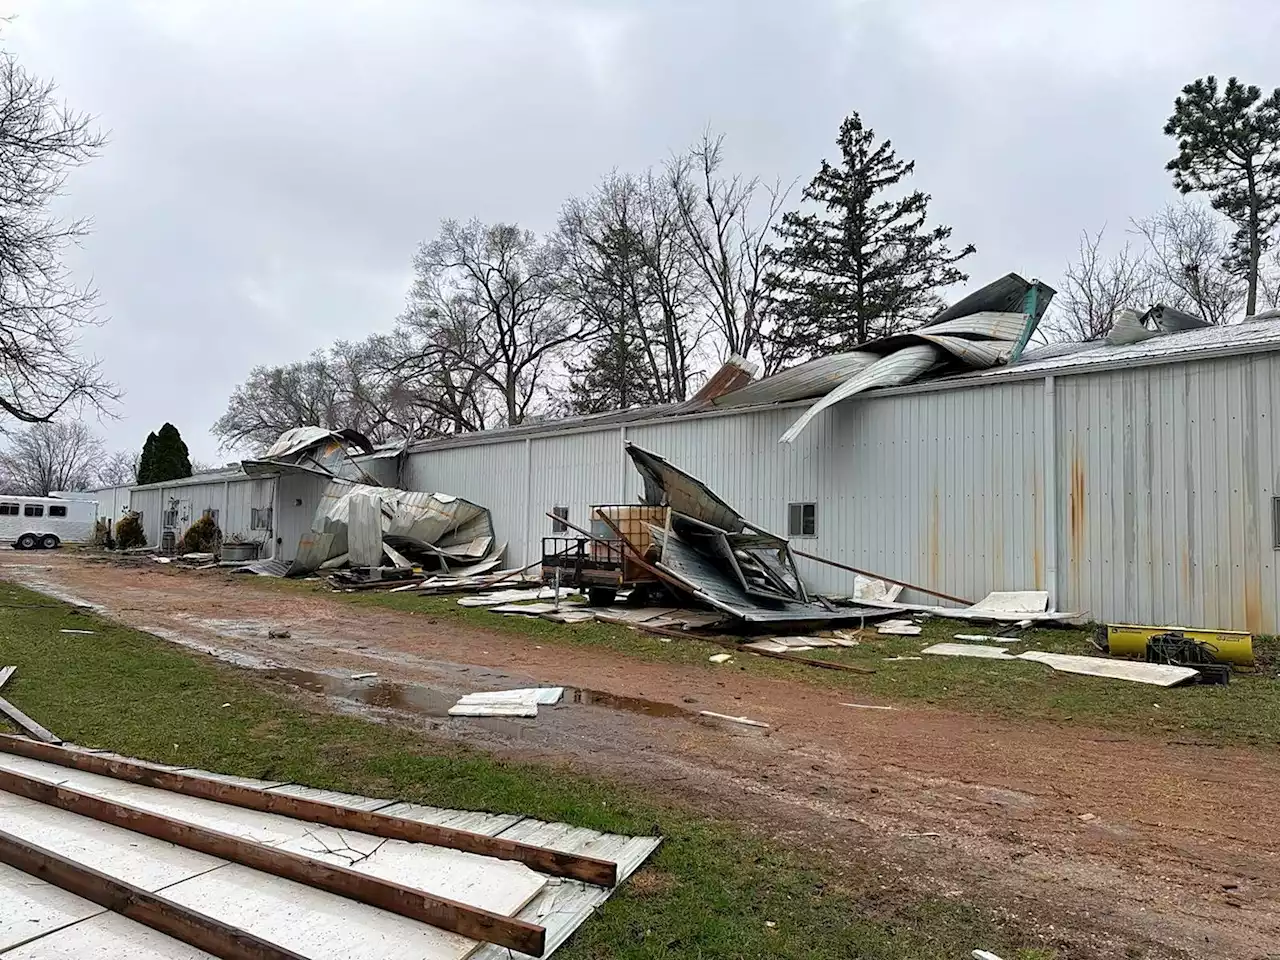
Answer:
xmin=0 ymin=831 xmax=305 ymax=960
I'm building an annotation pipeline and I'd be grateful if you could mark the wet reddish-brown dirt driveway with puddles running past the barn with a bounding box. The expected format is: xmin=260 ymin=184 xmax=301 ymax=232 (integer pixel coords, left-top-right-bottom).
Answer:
xmin=0 ymin=553 xmax=1280 ymax=960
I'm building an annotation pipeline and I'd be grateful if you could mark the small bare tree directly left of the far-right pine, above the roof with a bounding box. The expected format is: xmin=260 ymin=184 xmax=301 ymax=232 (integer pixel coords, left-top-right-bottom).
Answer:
xmin=1133 ymin=201 xmax=1247 ymax=324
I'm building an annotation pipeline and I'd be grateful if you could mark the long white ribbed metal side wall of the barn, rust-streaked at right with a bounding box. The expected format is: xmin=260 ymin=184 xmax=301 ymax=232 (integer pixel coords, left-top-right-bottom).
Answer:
xmin=403 ymin=352 xmax=1280 ymax=632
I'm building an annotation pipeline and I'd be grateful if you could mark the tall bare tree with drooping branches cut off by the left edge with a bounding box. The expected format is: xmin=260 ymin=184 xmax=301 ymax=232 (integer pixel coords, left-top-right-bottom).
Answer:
xmin=0 ymin=41 xmax=118 ymax=424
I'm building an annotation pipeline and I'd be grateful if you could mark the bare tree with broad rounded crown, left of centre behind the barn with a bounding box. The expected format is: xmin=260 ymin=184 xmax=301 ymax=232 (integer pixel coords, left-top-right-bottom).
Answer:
xmin=401 ymin=220 xmax=593 ymax=424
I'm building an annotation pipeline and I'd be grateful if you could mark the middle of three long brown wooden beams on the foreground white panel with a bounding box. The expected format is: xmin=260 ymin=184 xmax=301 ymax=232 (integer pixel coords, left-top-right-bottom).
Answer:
xmin=0 ymin=771 xmax=547 ymax=956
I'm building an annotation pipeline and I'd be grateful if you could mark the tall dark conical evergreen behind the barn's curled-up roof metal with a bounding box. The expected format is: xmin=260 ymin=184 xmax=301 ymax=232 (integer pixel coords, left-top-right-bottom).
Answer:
xmin=767 ymin=114 xmax=974 ymax=360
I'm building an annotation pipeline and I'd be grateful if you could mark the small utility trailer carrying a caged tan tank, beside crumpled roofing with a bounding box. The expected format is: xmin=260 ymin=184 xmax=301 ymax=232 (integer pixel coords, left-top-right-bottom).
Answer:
xmin=543 ymin=503 xmax=667 ymax=607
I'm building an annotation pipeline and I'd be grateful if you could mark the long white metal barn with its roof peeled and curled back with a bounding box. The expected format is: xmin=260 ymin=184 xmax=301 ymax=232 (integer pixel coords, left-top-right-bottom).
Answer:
xmin=115 ymin=274 xmax=1280 ymax=634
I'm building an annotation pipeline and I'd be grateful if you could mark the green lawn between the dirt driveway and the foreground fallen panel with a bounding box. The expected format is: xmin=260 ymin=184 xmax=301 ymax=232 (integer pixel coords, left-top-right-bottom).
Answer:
xmin=0 ymin=584 xmax=1056 ymax=960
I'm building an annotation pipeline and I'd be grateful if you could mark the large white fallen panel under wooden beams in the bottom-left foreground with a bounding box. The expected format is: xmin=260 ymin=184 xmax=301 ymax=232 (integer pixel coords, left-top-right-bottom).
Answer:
xmin=0 ymin=751 xmax=662 ymax=960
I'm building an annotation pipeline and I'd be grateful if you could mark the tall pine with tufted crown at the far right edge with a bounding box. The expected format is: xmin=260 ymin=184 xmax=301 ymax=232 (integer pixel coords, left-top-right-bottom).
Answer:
xmin=1165 ymin=77 xmax=1280 ymax=314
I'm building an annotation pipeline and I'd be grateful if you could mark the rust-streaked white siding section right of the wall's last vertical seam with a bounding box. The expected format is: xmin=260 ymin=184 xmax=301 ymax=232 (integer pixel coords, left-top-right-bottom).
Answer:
xmin=1059 ymin=353 xmax=1280 ymax=634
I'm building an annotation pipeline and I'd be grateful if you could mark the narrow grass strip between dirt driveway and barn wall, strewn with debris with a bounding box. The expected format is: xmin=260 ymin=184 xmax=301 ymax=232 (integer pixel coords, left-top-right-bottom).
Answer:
xmin=248 ymin=577 xmax=1280 ymax=748
